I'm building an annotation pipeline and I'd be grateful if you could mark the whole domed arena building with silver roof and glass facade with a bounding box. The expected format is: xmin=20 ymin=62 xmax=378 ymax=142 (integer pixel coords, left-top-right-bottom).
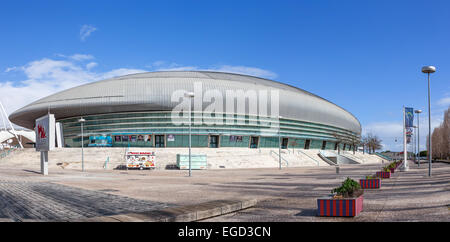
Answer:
xmin=9 ymin=71 xmax=361 ymax=150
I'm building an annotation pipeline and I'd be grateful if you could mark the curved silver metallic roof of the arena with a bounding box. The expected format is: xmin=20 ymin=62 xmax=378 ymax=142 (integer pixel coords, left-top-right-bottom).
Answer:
xmin=10 ymin=71 xmax=361 ymax=134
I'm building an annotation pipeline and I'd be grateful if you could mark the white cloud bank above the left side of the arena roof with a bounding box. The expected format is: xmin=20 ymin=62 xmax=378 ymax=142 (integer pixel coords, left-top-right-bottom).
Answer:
xmin=0 ymin=57 xmax=276 ymax=130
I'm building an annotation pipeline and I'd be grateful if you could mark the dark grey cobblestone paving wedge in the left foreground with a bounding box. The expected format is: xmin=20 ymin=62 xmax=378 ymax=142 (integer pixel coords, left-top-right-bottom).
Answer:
xmin=0 ymin=180 xmax=169 ymax=221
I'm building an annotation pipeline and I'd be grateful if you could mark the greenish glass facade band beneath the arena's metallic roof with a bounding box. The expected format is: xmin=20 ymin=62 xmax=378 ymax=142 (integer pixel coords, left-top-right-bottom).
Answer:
xmin=57 ymin=111 xmax=359 ymax=150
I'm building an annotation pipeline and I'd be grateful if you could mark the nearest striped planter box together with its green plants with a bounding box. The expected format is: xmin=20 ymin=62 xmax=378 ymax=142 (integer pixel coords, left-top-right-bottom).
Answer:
xmin=317 ymin=177 xmax=364 ymax=217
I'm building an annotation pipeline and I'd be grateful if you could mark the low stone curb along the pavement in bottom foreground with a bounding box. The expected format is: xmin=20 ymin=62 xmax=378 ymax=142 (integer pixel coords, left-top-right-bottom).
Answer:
xmin=70 ymin=199 xmax=258 ymax=222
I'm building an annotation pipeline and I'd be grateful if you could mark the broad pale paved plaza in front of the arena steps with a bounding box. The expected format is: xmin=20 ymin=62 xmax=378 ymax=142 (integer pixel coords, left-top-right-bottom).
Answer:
xmin=0 ymin=160 xmax=450 ymax=221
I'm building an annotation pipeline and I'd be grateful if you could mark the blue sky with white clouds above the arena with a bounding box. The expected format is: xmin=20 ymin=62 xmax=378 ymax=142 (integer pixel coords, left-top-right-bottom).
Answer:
xmin=0 ymin=0 xmax=450 ymax=150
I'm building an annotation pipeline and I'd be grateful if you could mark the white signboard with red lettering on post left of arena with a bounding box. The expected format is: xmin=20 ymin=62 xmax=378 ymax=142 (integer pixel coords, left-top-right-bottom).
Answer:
xmin=34 ymin=114 xmax=55 ymax=151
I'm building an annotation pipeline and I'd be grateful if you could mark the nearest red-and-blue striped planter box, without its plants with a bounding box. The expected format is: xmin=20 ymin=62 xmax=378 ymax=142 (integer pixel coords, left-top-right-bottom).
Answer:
xmin=317 ymin=195 xmax=364 ymax=217
